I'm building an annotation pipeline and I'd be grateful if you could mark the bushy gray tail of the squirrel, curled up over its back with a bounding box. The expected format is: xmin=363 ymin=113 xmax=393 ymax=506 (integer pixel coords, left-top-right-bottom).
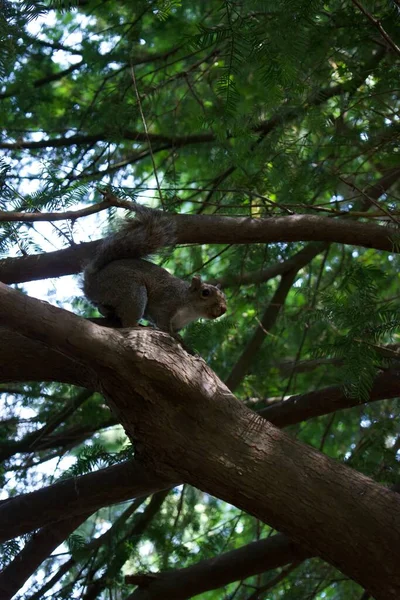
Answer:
xmin=84 ymin=205 xmax=176 ymax=279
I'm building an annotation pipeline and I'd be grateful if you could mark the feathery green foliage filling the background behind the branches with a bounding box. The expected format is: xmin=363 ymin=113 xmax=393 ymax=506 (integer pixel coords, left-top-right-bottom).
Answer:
xmin=0 ymin=0 xmax=400 ymax=600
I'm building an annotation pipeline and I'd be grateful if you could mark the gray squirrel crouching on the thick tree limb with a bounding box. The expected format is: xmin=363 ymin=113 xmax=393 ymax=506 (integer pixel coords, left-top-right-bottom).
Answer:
xmin=83 ymin=205 xmax=226 ymax=336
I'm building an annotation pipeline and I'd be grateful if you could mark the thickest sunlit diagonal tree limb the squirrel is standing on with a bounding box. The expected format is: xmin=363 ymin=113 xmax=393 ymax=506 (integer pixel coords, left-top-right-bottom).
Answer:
xmin=0 ymin=285 xmax=400 ymax=600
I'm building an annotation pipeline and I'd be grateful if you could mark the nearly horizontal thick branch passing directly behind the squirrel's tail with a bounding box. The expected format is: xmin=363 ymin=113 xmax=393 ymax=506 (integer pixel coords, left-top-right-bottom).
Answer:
xmin=0 ymin=211 xmax=400 ymax=283
